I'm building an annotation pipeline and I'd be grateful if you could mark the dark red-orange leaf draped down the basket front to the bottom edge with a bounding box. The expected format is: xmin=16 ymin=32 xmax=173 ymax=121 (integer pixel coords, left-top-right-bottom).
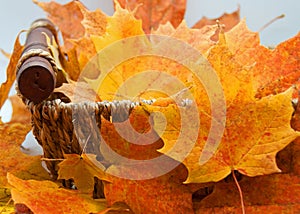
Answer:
xmin=101 ymin=102 xmax=192 ymax=213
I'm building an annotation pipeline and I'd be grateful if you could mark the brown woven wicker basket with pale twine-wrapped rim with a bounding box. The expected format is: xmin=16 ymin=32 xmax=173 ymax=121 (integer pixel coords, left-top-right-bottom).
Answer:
xmin=25 ymin=93 xmax=153 ymax=198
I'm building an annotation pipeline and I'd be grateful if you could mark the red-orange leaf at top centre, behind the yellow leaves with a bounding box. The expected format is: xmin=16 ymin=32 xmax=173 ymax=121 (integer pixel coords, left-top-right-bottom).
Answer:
xmin=115 ymin=0 xmax=186 ymax=33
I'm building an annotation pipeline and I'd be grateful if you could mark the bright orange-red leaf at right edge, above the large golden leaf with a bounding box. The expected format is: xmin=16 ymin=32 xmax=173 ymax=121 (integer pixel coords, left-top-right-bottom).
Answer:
xmin=253 ymin=33 xmax=300 ymax=97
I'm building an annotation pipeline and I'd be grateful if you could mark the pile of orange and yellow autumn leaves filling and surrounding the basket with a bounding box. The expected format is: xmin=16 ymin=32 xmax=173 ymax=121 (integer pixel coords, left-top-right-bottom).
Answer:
xmin=0 ymin=0 xmax=300 ymax=213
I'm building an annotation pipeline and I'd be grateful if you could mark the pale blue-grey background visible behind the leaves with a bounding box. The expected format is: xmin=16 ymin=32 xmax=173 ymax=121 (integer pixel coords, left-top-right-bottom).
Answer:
xmin=0 ymin=0 xmax=300 ymax=120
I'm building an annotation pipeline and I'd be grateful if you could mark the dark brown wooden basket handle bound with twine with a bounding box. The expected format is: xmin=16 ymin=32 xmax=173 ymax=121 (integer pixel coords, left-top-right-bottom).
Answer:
xmin=17 ymin=19 xmax=57 ymax=103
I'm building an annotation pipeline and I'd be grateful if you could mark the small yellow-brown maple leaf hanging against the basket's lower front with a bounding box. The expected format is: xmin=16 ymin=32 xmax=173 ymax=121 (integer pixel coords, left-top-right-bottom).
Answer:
xmin=58 ymin=154 xmax=109 ymax=193
